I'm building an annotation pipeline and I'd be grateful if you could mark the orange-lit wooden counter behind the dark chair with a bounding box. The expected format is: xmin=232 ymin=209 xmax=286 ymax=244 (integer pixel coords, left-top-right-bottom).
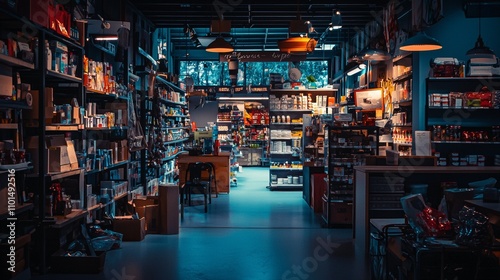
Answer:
xmin=177 ymin=154 xmax=230 ymax=193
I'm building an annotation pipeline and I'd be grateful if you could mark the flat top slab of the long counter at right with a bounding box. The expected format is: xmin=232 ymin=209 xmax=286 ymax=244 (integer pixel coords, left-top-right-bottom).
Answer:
xmin=354 ymin=165 xmax=500 ymax=173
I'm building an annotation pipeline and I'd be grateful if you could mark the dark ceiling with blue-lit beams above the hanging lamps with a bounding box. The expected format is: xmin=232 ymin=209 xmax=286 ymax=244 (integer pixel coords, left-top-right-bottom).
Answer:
xmin=131 ymin=0 xmax=396 ymax=50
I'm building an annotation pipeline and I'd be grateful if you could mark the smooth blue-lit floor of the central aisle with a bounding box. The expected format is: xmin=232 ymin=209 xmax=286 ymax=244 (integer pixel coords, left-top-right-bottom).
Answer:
xmin=30 ymin=167 xmax=369 ymax=280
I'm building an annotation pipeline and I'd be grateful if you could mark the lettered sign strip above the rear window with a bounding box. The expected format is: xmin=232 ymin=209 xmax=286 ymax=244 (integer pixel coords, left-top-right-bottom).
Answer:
xmin=219 ymin=52 xmax=306 ymax=62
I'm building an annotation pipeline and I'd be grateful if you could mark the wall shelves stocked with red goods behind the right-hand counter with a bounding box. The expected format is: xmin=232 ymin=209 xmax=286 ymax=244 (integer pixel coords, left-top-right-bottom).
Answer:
xmin=425 ymin=77 xmax=500 ymax=166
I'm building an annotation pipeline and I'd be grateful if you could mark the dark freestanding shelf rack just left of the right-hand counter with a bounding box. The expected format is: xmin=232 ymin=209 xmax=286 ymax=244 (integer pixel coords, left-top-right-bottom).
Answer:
xmin=322 ymin=125 xmax=379 ymax=227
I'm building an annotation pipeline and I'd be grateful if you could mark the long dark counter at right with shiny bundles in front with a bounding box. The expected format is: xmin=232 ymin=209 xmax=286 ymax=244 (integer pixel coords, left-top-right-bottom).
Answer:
xmin=353 ymin=166 xmax=500 ymax=256
